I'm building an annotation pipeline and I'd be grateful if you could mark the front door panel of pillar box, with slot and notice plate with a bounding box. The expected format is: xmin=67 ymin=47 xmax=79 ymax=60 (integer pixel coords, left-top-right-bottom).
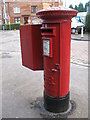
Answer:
xmin=42 ymin=24 xmax=60 ymax=97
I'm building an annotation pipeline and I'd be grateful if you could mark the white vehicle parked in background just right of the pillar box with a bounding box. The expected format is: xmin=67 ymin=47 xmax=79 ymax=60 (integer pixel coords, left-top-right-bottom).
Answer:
xmin=71 ymin=17 xmax=85 ymax=34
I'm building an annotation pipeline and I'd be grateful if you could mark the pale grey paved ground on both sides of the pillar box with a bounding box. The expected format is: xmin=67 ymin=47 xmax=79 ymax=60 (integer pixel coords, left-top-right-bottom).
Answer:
xmin=0 ymin=31 xmax=90 ymax=118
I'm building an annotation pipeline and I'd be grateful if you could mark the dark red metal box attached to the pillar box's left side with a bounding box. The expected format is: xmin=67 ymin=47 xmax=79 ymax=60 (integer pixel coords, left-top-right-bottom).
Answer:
xmin=20 ymin=25 xmax=43 ymax=70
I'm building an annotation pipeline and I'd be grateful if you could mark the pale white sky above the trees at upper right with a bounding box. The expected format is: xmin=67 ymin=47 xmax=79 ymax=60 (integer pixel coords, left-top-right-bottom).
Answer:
xmin=62 ymin=0 xmax=90 ymax=7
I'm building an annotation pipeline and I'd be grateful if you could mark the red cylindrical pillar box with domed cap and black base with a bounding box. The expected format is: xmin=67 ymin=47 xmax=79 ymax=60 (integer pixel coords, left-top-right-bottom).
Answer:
xmin=36 ymin=7 xmax=77 ymax=113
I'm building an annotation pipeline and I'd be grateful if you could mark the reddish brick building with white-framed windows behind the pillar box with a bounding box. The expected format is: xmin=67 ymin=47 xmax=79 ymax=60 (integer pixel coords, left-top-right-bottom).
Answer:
xmin=2 ymin=0 xmax=60 ymax=23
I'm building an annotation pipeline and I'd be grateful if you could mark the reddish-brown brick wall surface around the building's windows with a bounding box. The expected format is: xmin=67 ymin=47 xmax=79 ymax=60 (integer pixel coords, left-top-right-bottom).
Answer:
xmin=1 ymin=0 xmax=58 ymax=23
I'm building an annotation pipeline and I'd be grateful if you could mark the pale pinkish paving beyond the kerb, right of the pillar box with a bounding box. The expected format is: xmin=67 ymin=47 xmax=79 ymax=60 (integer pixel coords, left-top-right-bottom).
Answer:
xmin=71 ymin=40 xmax=90 ymax=66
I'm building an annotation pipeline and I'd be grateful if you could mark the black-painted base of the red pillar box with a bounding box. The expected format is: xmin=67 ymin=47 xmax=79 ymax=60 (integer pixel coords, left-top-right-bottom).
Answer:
xmin=44 ymin=92 xmax=70 ymax=113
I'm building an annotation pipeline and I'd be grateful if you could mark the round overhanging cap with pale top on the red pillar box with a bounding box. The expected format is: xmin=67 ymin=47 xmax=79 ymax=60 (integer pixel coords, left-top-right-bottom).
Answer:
xmin=36 ymin=6 xmax=77 ymax=22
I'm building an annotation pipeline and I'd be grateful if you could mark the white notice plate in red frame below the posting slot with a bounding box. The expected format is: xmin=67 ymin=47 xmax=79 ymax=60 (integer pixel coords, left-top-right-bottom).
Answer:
xmin=43 ymin=38 xmax=52 ymax=57
